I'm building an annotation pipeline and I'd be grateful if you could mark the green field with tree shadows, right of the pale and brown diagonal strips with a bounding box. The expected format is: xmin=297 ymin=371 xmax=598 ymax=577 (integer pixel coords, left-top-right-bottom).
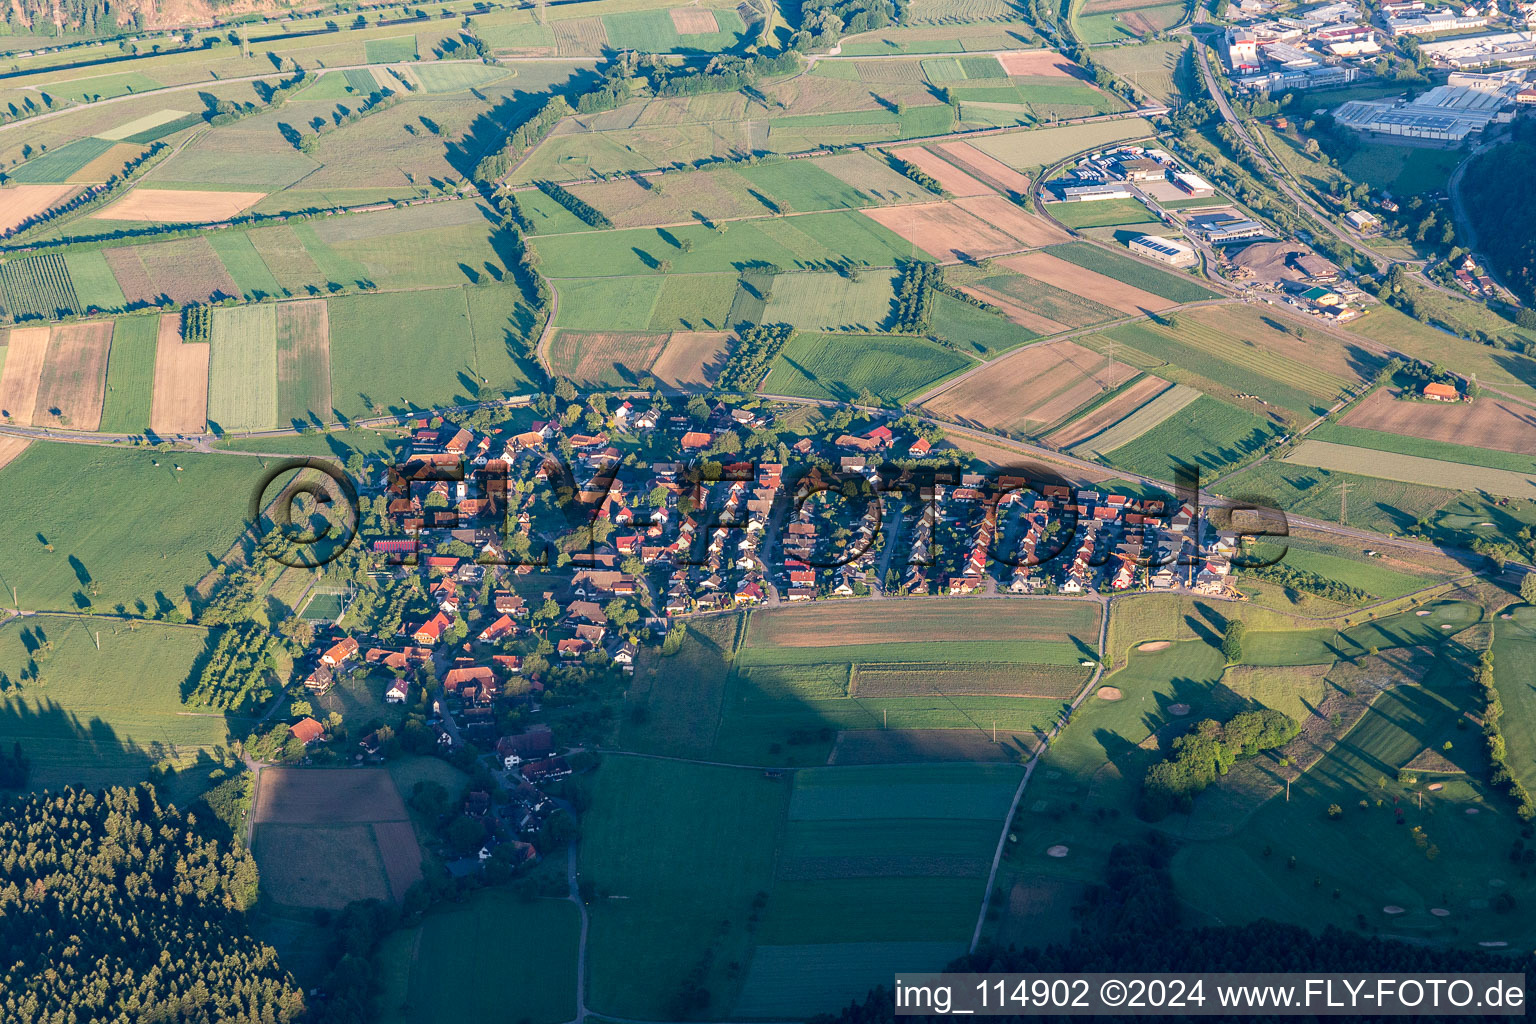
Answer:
xmin=1104 ymin=395 xmax=1279 ymax=481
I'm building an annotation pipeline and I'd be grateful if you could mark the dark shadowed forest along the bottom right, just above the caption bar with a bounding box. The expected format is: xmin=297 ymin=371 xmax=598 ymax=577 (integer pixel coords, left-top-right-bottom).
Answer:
xmin=816 ymin=834 xmax=1536 ymax=1024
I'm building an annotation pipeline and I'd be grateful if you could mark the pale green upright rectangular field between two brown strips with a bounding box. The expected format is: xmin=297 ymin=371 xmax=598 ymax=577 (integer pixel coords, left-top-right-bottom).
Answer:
xmin=207 ymin=306 xmax=278 ymax=430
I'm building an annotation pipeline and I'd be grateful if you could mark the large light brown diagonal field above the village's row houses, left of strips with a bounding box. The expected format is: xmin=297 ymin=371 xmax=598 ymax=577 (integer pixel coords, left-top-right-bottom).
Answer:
xmin=923 ymin=341 xmax=1135 ymax=431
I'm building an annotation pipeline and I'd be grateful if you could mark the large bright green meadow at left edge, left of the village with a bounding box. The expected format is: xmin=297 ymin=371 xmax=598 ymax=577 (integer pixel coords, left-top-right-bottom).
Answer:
xmin=0 ymin=441 xmax=260 ymax=613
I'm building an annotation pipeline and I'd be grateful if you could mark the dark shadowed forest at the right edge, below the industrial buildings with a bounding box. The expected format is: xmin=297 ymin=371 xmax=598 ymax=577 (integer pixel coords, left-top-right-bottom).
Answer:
xmin=1461 ymin=118 xmax=1536 ymax=299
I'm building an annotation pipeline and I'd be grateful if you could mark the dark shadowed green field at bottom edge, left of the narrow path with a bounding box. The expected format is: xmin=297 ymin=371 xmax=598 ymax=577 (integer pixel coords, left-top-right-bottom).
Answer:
xmin=379 ymin=884 xmax=581 ymax=1024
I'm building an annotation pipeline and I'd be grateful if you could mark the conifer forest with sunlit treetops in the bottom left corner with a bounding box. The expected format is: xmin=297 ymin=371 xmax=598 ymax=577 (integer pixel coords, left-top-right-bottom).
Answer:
xmin=0 ymin=786 xmax=304 ymax=1024
